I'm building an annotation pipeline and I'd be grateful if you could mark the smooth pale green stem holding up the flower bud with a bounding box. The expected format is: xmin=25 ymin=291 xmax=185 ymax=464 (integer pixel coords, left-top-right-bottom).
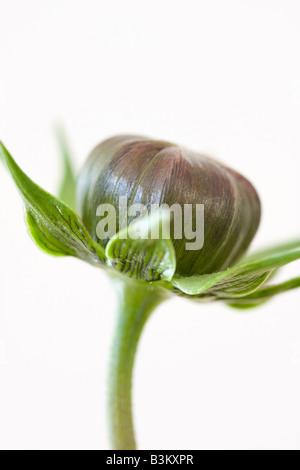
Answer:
xmin=109 ymin=278 xmax=164 ymax=450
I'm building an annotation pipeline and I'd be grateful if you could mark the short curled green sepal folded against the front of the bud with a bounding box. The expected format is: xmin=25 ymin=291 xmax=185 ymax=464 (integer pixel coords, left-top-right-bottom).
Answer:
xmin=105 ymin=210 xmax=176 ymax=282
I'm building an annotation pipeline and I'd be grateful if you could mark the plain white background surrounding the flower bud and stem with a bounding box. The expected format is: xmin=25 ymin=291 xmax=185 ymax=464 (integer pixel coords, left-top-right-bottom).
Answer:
xmin=0 ymin=0 xmax=300 ymax=449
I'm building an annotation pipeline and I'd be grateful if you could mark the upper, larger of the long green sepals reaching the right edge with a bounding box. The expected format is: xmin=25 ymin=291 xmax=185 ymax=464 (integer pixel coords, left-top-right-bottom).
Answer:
xmin=172 ymin=240 xmax=300 ymax=299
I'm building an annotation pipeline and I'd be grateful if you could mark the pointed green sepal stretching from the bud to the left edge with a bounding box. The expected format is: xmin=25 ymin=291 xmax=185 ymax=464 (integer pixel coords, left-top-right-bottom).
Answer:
xmin=0 ymin=142 xmax=105 ymax=265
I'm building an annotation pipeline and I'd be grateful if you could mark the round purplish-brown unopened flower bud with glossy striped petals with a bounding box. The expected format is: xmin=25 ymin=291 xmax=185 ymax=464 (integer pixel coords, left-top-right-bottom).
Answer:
xmin=78 ymin=136 xmax=261 ymax=276
